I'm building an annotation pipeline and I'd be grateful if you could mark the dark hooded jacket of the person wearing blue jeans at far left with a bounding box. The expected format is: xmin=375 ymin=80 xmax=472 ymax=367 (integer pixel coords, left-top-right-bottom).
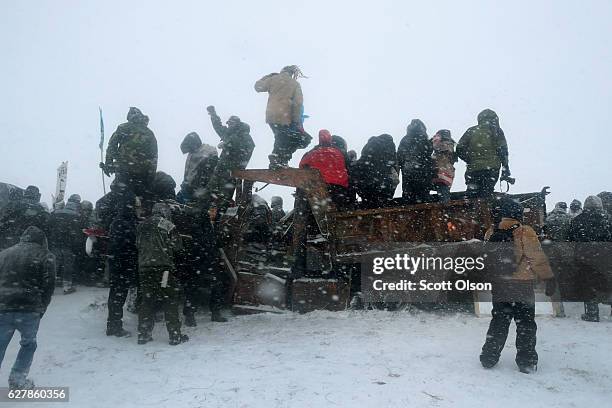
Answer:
xmin=0 ymin=226 xmax=55 ymax=313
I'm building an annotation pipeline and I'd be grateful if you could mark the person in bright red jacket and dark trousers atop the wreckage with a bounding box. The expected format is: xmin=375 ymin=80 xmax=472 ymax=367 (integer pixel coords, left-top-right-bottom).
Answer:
xmin=300 ymin=129 xmax=350 ymax=208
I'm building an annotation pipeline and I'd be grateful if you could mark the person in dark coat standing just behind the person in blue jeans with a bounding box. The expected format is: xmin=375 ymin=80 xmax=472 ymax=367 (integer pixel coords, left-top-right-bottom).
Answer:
xmin=49 ymin=200 xmax=85 ymax=295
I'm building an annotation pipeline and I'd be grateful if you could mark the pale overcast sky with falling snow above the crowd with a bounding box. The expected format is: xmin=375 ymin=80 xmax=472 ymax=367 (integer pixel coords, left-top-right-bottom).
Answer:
xmin=0 ymin=0 xmax=612 ymax=209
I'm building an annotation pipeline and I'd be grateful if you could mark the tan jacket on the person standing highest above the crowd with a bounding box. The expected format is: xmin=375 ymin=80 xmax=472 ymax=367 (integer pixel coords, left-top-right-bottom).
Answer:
xmin=255 ymin=72 xmax=304 ymax=125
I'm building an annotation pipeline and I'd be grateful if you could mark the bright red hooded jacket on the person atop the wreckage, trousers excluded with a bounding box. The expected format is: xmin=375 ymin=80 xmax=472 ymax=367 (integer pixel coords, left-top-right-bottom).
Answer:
xmin=300 ymin=129 xmax=349 ymax=188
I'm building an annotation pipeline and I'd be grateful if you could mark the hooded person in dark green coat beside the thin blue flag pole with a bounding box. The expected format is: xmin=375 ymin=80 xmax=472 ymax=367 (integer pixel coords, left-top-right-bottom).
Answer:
xmin=100 ymin=107 xmax=157 ymax=199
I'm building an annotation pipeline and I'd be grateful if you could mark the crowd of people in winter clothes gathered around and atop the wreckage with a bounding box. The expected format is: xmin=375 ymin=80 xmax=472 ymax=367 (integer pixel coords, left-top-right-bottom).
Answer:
xmin=0 ymin=66 xmax=612 ymax=387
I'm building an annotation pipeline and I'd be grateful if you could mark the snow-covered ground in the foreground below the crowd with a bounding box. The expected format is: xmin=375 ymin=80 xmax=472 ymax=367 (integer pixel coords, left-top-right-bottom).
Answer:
xmin=0 ymin=288 xmax=612 ymax=408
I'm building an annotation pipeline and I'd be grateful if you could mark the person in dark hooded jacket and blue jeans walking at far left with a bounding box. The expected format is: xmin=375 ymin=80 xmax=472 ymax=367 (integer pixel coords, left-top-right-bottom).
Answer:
xmin=0 ymin=226 xmax=55 ymax=389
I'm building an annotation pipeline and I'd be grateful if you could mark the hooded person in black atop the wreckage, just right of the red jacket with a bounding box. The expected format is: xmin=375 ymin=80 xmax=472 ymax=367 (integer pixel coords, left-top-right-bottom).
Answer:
xmin=351 ymin=134 xmax=399 ymax=208
